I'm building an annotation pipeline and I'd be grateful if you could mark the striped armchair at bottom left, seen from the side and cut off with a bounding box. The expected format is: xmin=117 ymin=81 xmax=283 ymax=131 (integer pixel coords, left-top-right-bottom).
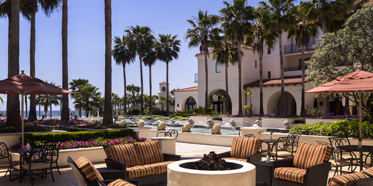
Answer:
xmin=67 ymin=156 xmax=137 ymax=186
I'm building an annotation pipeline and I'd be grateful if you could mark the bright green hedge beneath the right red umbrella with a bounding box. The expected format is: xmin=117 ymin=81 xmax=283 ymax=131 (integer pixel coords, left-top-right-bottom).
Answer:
xmin=290 ymin=119 xmax=373 ymax=138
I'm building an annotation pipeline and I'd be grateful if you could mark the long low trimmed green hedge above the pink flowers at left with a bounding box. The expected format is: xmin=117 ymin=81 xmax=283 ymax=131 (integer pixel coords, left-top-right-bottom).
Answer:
xmin=25 ymin=129 xmax=136 ymax=144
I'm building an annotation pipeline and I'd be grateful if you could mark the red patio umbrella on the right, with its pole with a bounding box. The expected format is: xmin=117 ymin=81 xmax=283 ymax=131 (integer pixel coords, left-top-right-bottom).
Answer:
xmin=306 ymin=70 xmax=373 ymax=145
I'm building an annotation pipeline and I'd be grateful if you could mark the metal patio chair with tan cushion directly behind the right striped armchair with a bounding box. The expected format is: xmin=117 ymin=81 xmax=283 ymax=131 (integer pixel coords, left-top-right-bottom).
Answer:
xmin=271 ymin=135 xmax=298 ymax=160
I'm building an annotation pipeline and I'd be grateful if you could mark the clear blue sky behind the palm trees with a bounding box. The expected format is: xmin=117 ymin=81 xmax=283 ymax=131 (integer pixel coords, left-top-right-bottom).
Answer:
xmin=0 ymin=0 xmax=259 ymax=110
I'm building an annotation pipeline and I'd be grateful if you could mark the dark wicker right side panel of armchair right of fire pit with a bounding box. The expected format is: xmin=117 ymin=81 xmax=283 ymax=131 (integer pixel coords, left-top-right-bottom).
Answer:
xmin=304 ymin=162 xmax=331 ymax=185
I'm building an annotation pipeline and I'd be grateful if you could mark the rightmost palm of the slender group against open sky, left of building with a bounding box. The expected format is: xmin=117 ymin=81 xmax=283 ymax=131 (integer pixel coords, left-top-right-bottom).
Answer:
xmin=155 ymin=34 xmax=181 ymax=114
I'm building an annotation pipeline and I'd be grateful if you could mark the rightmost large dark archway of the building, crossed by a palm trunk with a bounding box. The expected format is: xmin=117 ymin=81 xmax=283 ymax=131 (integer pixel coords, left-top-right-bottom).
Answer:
xmin=267 ymin=91 xmax=297 ymax=117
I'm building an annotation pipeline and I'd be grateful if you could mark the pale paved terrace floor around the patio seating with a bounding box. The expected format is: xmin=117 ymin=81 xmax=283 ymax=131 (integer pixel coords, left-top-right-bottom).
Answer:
xmin=0 ymin=142 xmax=340 ymax=186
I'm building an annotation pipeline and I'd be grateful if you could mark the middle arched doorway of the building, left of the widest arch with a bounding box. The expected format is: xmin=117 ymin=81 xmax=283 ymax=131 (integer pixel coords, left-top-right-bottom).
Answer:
xmin=208 ymin=89 xmax=232 ymax=114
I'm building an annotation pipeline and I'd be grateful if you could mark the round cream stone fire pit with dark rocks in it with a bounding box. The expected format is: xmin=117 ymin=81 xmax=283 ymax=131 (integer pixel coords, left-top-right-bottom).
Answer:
xmin=167 ymin=159 xmax=256 ymax=186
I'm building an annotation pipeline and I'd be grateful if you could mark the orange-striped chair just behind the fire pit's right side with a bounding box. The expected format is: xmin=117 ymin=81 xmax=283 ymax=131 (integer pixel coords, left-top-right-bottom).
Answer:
xmin=218 ymin=137 xmax=262 ymax=163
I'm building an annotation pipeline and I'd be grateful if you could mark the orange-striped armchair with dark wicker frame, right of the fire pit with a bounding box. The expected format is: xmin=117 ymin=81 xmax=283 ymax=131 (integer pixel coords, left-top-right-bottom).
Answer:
xmin=273 ymin=143 xmax=332 ymax=186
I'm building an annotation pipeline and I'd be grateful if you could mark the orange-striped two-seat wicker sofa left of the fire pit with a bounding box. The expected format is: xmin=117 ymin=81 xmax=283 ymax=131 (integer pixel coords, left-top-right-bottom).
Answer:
xmin=98 ymin=141 xmax=181 ymax=185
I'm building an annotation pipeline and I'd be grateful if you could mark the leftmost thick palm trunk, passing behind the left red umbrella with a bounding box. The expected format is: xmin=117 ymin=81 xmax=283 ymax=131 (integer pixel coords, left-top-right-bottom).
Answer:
xmin=6 ymin=0 xmax=21 ymax=126
